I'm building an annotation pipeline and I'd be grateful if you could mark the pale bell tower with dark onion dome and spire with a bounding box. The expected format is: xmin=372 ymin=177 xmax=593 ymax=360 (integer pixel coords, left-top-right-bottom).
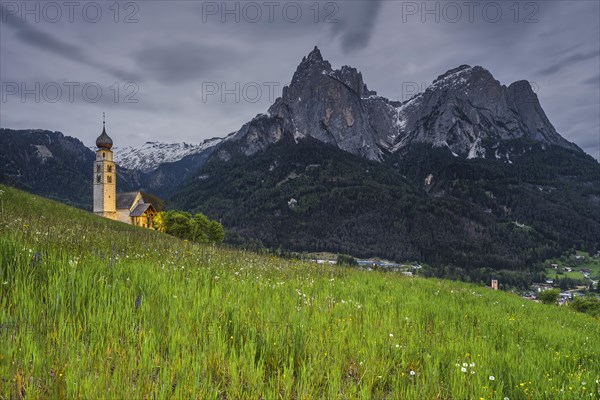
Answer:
xmin=93 ymin=113 xmax=117 ymax=219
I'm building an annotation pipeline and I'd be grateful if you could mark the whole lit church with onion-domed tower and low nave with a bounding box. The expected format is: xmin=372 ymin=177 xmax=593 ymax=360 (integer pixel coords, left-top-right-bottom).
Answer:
xmin=93 ymin=115 xmax=157 ymax=229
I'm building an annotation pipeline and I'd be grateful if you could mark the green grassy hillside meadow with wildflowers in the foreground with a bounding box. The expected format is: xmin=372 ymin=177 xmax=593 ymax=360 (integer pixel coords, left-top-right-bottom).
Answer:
xmin=0 ymin=186 xmax=600 ymax=400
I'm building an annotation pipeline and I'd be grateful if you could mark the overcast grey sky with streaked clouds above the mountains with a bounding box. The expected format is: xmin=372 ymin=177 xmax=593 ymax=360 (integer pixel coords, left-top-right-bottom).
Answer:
xmin=0 ymin=0 xmax=600 ymax=157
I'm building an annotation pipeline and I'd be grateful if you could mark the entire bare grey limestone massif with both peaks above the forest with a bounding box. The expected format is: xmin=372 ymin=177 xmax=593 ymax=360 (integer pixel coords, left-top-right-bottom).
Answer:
xmin=226 ymin=47 xmax=581 ymax=161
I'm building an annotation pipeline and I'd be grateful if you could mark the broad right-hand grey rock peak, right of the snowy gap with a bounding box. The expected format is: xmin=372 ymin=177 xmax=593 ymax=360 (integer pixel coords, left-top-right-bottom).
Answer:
xmin=395 ymin=65 xmax=578 ymax=158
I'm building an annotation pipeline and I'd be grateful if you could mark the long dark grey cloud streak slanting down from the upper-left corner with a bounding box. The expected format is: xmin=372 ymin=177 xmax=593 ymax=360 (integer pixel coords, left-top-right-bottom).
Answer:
xmin=0 ymin=6 xmax=140 ymax=82
